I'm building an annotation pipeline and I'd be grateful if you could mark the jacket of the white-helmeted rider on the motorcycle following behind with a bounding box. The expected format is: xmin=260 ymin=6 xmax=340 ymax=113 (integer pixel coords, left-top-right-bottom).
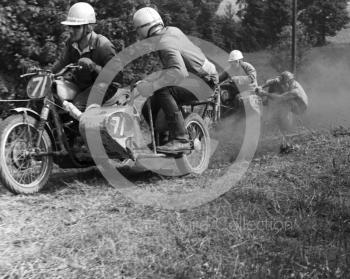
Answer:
xmin=219 ymin=61 xmax=258 ymax=92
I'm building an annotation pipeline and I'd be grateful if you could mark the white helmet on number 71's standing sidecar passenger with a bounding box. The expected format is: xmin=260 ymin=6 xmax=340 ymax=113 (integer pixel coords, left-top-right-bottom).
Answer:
xmin=133 ymin=7 xmax=164 ymax=38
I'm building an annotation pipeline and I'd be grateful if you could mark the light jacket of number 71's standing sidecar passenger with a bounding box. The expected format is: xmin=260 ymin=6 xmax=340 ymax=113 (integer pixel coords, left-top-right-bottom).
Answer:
xmin=150 ymin=26 xmax=217 ymax=91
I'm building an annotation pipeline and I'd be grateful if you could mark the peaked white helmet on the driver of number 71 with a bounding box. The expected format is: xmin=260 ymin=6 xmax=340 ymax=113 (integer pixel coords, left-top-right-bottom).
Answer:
xmin=61 ymin=2 xmax=96 ymax=25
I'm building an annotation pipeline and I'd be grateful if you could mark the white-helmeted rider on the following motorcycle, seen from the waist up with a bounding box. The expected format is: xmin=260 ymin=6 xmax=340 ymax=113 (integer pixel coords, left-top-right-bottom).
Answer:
xmin=219 ymin=49 xmax=257 ymax=94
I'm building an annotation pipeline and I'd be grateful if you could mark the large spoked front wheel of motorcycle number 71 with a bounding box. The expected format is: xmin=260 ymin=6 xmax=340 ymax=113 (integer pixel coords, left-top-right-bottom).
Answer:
xmin=0 ymin=115 xmax=52 ymax=194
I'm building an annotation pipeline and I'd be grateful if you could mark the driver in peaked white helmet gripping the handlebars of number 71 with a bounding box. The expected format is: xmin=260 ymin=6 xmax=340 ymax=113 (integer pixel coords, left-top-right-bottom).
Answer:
xmin=52 ymin=2 xmax=116 ymax=109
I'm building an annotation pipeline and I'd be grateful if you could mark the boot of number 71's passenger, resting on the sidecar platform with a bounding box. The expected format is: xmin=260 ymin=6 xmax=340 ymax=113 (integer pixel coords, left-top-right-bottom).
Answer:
xmin=157 ymin=111 xmax=191 ymax=153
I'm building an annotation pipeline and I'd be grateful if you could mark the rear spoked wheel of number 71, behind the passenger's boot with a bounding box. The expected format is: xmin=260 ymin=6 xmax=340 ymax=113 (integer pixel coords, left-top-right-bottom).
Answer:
xmin=176 ymin=113 xmax=210 ymax=174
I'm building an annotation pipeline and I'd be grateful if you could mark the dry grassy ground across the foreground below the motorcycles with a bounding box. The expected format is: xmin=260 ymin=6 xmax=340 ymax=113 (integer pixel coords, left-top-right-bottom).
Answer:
xmin=0 ymin=130 xmax=350 ymax=278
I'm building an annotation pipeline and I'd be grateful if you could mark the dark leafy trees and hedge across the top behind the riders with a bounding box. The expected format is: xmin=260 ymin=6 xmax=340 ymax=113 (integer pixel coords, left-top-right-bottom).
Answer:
xmin=0 ymin=0 xmax=348 ymax=89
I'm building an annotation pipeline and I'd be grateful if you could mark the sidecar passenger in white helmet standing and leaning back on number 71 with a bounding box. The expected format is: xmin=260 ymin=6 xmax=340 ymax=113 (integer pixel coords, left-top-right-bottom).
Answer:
xmin=133 ymin=7 xmax=217 ymax=153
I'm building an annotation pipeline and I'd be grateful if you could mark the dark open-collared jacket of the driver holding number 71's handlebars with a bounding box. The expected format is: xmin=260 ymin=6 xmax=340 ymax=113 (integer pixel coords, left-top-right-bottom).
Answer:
xmin=52 ymin=32 xmax=116 ymax=90
